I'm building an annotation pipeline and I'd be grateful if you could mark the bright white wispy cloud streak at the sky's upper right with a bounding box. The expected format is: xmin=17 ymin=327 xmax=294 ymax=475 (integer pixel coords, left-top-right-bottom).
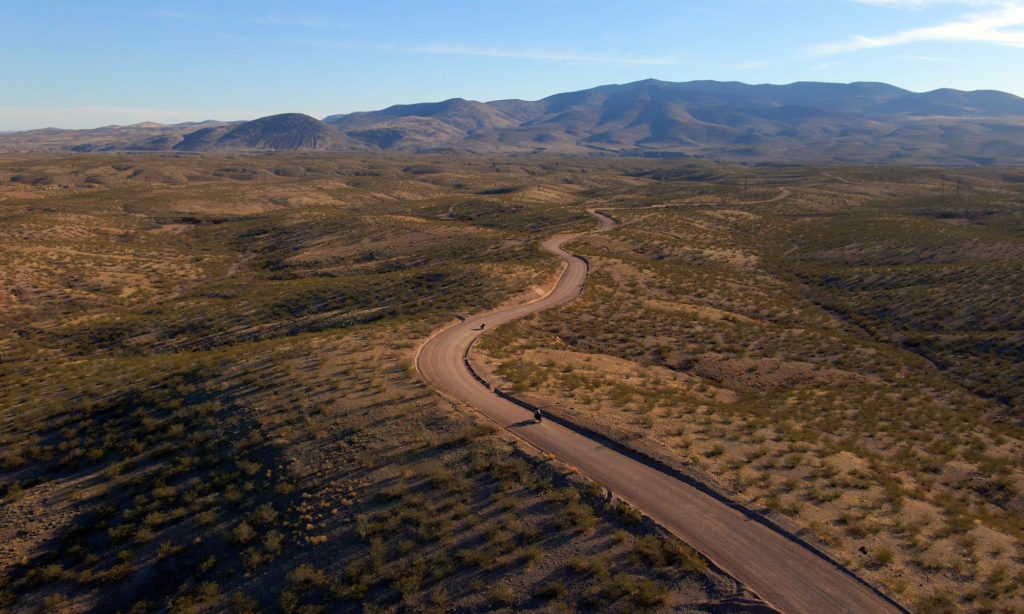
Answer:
xmin=812 ymin=0 xmax=1024 ymax=55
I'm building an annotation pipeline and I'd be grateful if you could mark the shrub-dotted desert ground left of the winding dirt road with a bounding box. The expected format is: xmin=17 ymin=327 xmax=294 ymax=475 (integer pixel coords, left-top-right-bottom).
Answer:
xmin=0 ymin=155 xmax=761 ymax=612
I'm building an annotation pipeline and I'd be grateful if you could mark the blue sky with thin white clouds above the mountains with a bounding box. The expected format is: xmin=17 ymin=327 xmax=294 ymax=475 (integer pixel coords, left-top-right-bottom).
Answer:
xmin=0 ymin=0 xmax=1024 ymax=130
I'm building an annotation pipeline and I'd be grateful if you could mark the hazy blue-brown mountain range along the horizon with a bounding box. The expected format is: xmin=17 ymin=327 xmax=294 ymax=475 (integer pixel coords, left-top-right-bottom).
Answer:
xmin=6 ymin=79 xmax=1024 ymax=165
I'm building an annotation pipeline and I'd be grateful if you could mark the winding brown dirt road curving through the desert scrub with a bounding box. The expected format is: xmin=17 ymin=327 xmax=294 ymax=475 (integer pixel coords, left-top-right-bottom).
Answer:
xmin=416 ymin=210 xmax=903 ymax=614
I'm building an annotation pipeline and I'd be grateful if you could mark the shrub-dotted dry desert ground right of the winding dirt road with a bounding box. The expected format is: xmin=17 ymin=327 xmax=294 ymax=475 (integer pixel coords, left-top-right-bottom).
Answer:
xmin=477 ymin=169 xmax=1024 ymax=612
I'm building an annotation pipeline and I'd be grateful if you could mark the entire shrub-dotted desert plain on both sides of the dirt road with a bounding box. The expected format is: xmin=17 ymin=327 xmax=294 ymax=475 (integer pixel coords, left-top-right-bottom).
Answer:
xmin=8 ymin=155 xmax=1024 ymax=612
